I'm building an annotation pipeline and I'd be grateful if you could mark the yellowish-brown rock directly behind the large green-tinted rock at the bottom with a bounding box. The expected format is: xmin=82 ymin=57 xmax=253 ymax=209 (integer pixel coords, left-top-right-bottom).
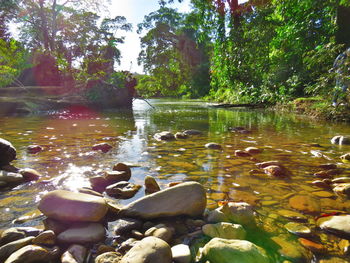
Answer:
xmin=202 ymin=222 xmax=247 ymax=239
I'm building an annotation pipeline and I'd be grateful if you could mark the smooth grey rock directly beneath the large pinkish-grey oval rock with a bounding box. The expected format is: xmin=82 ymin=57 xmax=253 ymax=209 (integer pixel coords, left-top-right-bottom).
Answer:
xmin=57 ymin=223 xmax=106 ymax=244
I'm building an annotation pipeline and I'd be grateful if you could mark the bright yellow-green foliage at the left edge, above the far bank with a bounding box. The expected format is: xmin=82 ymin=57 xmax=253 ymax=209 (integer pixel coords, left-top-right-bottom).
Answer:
xmin=0 ymin=39 xmax=29 ymax=87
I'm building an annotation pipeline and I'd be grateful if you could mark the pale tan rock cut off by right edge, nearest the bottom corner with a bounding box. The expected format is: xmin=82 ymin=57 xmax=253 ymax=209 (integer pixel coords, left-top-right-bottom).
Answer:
xmin=317 ymin=215 xmax=350 ymax=238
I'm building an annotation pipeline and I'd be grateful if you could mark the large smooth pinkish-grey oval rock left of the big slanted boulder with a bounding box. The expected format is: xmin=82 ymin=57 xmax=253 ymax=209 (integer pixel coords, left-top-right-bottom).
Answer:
xmin=38 ymin=190 xmax=108 ymax=222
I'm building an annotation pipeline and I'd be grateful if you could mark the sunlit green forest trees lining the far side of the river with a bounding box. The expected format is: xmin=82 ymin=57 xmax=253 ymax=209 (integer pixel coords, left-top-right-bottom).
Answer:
xmin=0 ymin=0 xmax=350 ymax=104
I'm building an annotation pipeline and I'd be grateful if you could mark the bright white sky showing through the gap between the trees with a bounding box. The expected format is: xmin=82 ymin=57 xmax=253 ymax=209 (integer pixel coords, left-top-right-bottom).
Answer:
xmin=109 ymin=0 xmax=190 ymax=73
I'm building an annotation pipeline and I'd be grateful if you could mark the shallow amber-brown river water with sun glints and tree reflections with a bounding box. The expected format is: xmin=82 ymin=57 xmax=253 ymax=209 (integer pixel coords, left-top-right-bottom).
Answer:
xmin=0 ymin=100 xmax=350 ymax=262
